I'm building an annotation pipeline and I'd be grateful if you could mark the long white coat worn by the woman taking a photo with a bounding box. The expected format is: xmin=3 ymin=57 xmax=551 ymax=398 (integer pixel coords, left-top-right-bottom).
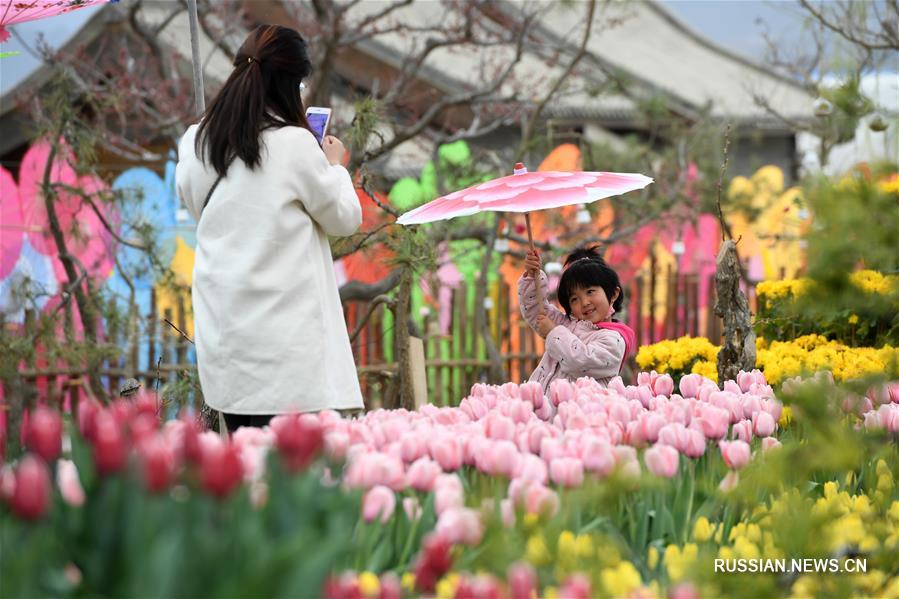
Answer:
xmin=175 ymin=125 xmax=363 ymax=414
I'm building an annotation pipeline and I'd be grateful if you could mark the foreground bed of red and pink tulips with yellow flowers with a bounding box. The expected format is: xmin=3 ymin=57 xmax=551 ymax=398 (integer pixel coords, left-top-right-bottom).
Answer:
xmin=0 ymin=371 xmax=899 ymax=597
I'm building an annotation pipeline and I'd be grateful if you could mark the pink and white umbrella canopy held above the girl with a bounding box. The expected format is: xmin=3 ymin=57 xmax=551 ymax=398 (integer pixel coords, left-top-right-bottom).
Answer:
xmin=396 ymin=163 xmax=652 ymax=225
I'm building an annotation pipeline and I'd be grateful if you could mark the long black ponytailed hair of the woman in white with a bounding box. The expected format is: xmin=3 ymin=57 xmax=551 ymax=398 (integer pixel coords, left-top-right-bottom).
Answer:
xmin=195 ymin=25 xmax=312 ymax=177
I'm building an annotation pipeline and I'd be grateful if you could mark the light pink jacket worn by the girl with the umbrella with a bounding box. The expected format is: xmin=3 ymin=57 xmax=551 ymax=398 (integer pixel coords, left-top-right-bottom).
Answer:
xmin=518 ymin=271 xmax=636 ymax=393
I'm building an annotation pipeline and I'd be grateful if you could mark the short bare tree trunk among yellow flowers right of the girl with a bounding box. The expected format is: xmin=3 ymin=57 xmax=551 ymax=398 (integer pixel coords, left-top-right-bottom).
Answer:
xmin=715 ymin=239 xmax=755 ymax=384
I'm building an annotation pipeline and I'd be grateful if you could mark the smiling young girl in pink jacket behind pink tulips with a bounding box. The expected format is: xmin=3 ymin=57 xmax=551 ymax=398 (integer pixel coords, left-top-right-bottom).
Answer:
xmin=518 ymin=248 xmax=637 ymax=393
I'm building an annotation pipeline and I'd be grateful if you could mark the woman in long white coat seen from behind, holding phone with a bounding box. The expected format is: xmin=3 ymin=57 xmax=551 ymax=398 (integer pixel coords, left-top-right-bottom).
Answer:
xmin=176 ymin=25 xmax=363 ymax=430
